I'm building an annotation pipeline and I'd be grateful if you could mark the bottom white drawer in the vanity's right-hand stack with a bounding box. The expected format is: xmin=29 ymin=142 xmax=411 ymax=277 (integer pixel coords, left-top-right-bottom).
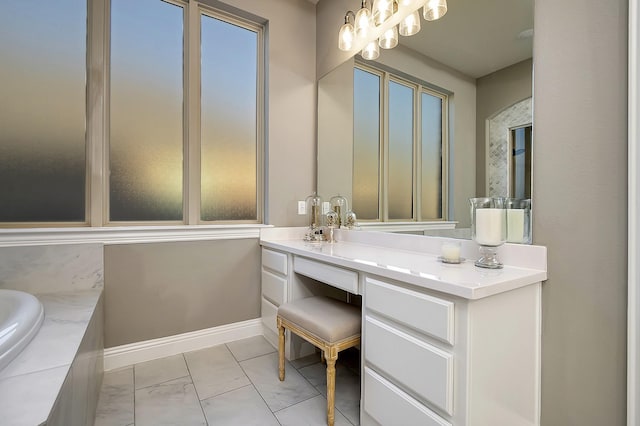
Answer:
xmin=363 ymin=367 xmax=451 ymax=426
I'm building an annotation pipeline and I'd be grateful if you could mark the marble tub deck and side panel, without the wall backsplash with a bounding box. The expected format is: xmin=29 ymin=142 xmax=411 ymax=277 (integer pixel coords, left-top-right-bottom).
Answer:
xmin=0 ymin=288 xmax=103 ymax=426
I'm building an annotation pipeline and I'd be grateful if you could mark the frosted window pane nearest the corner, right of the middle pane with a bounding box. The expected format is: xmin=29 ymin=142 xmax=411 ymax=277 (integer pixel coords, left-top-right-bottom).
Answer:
xmin=200 ymin=15 xmax=258 ymax=221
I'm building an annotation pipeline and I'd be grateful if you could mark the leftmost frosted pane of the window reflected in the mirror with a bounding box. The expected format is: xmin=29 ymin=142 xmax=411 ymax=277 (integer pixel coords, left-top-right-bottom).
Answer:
xmin=353 ymin=68 xmax=380 ymax=220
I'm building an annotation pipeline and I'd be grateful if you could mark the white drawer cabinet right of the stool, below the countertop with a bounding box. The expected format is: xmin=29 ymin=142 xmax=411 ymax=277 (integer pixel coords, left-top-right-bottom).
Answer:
xmin=361 ymin=276 xmax=540 ymax=426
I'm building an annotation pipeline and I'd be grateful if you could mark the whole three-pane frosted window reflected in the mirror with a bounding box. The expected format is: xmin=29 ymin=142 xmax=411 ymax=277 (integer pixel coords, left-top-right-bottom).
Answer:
xmin=352 ymin=64 xmax=448 ymax=221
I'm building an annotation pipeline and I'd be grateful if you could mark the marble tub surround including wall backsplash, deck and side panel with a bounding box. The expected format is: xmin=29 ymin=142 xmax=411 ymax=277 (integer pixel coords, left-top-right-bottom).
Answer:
xmin=0 ymin=243 xmax=104 ymax=426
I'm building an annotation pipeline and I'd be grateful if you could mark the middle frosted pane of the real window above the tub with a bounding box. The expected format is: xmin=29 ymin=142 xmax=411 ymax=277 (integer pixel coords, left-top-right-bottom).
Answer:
xmin=109 ymin=0 xmax=183 ymax=221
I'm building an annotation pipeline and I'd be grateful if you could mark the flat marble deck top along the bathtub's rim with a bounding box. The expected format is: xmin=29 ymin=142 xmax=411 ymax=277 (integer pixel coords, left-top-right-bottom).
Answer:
xmin=0 ymin=288 xmax=102 ymax=425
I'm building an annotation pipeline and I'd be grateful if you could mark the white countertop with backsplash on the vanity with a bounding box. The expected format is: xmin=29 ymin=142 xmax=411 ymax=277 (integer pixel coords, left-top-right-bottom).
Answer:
xmin=260 ymin=228 xmax=547 ymax=299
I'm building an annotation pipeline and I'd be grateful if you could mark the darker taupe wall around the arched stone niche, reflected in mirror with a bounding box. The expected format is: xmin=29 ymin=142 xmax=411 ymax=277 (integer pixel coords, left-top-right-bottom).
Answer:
xmin=476 ymin=59 xmax=535 ymax=197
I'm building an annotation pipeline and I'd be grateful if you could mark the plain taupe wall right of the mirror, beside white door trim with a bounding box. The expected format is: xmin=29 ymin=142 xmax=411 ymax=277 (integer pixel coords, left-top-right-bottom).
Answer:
xmin=533 ymin=0 xmax=627 ymax=426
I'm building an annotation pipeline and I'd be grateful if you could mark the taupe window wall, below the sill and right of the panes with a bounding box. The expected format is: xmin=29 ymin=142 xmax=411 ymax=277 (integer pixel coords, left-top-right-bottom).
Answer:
xmin=105 ymin=0 xmax=316 ymax=347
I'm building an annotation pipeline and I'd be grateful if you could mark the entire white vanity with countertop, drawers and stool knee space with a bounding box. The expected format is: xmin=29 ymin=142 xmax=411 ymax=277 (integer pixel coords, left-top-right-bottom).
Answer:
xmin=261 ymin=230 xmax=546 ymax=426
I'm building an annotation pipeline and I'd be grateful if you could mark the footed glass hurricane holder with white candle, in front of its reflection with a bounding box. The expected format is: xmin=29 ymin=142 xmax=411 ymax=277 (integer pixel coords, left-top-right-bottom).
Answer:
xmin=469 ymin=197 xmax=507 ymax=269
